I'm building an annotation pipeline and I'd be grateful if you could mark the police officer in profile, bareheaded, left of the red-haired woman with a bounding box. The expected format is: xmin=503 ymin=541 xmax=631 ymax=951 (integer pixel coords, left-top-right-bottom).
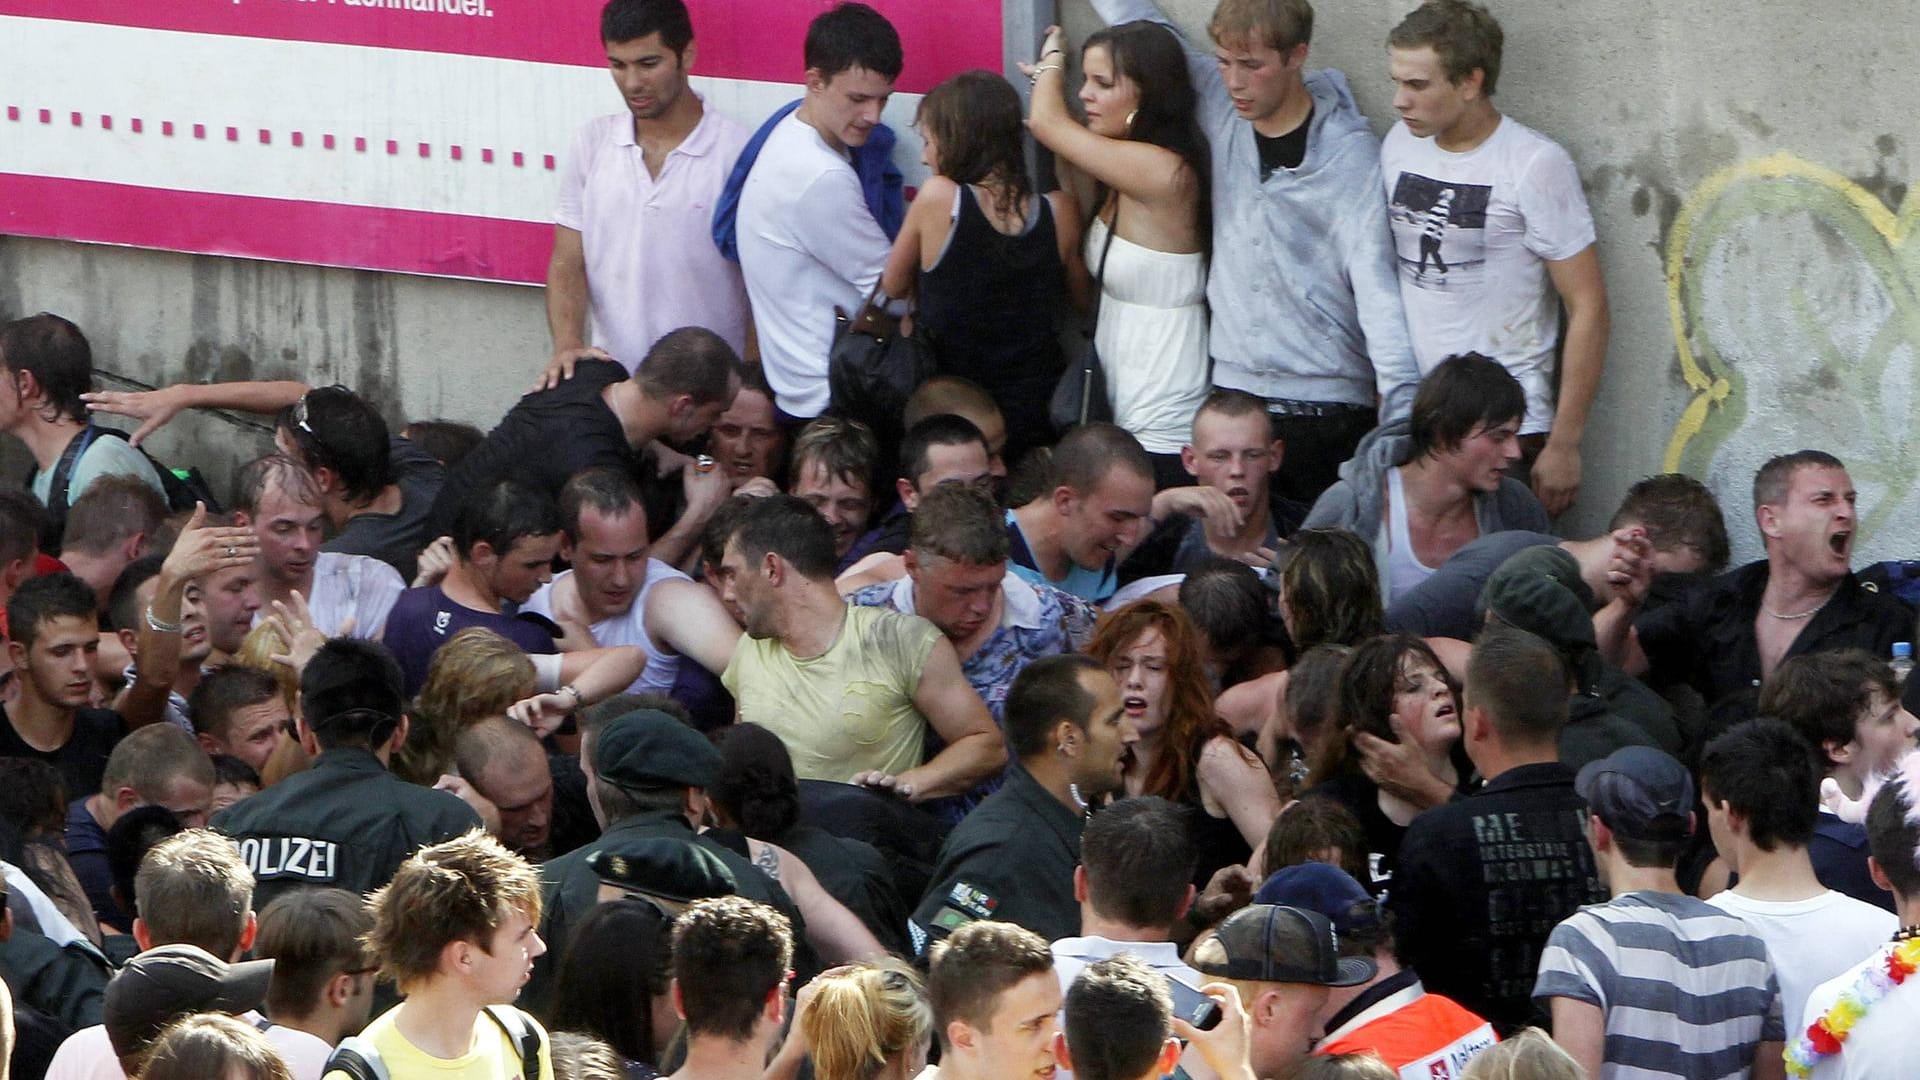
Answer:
xmin=908 ymin=653 xmax=1140 ymax=957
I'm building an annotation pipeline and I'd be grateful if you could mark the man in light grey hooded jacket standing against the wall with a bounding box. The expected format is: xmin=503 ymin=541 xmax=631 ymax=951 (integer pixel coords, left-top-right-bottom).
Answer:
xmin=1092 ymin=0 xmax=1419 ymax=503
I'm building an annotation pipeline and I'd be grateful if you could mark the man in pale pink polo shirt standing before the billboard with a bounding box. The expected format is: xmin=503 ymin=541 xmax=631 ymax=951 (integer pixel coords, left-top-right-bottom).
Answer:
xmin=541 ymin=0 xmax=749 ymax=386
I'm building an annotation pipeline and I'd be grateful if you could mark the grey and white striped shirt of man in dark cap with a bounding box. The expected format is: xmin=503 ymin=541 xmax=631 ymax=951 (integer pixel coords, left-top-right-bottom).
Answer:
xmin=1534 ymin=892 xmax=1786 ymax=1080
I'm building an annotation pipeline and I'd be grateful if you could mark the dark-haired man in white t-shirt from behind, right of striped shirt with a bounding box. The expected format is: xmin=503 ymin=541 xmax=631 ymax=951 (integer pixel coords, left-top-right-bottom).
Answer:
xmin=1699 ymin=719 xmax=1899 ymax=1032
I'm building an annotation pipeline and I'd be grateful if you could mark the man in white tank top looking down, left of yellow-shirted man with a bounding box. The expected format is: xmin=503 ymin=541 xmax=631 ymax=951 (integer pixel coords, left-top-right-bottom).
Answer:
xmin=522 ymin=469 xmax=739 ymax=694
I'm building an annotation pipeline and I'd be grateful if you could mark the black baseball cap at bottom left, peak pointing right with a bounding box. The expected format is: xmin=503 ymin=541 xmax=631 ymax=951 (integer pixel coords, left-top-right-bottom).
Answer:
xmin=100 ymin=945 xmax=273 ymax=1057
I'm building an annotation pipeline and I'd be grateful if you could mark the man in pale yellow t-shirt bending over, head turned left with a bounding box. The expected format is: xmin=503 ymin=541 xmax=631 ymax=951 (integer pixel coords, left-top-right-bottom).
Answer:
xmin=720 ymin=496 xmax=1006 ymax=801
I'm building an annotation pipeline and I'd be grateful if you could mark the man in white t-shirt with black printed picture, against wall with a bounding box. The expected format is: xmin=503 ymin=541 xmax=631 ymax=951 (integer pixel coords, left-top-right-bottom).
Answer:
xmin=1380 ymin=0 xmax=1607 ymax=515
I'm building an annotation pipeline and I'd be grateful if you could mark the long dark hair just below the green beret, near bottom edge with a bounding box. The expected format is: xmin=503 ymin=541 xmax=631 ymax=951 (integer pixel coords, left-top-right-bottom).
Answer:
xmin=553 ymin=897 xmax=674 ymax=1065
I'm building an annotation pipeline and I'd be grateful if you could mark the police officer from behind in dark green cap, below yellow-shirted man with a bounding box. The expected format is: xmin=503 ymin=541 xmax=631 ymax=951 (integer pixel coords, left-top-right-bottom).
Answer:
xmin=520 ymin=709 xmax=818 ymax=1011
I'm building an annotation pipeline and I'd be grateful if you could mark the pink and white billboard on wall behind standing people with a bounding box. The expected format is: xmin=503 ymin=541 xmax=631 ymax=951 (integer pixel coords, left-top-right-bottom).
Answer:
xmin=0 ymin=0 xmax=1002 ymax=282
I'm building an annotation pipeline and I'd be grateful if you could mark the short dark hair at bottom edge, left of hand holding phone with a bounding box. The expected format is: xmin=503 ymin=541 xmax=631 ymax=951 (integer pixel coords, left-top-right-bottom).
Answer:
xmin=1060 ymin=953 xmax=1173 ymax=1080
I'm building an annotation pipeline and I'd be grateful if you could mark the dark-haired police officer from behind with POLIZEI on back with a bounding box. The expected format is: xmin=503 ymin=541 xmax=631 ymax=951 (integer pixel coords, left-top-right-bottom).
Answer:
xmin=213 ymin=638 xmax=480 ymax=909
